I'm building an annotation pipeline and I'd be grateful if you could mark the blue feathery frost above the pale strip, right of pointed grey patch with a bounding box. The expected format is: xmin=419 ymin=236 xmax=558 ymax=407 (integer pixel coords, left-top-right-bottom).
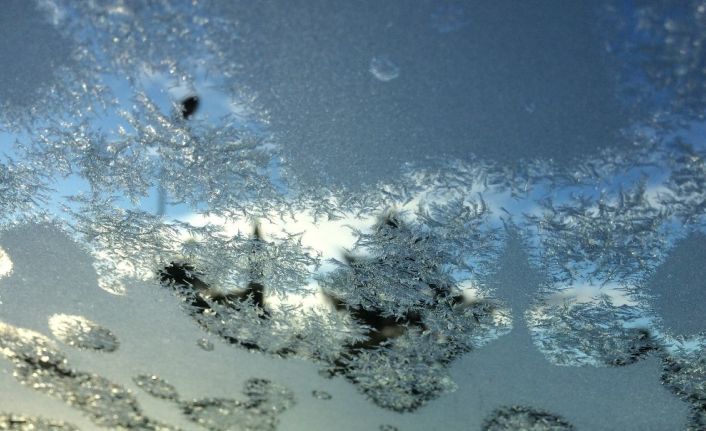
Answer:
xmin=528 ymin=182 xmax=668 ymax=285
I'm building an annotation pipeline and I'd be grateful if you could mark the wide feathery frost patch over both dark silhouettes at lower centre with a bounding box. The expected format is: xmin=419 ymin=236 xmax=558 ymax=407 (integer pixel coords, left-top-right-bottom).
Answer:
xmin=156 ymin=209 xmax=510 ymax=411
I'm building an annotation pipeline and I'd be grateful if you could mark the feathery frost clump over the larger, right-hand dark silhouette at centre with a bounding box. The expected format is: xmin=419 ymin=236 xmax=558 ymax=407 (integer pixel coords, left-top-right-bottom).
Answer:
xmin=321 ymin=212 xmax=509 ymax=411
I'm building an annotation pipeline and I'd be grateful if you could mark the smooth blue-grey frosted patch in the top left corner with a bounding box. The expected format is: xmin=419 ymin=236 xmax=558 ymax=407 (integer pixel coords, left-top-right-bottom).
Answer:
xmin=0 ymin=1 xmax=106 ymax=132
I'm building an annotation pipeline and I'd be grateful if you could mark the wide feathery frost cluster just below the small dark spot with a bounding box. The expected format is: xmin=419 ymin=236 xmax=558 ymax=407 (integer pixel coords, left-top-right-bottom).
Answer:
xmin=24 ymin=92 xmax=274 ymax=211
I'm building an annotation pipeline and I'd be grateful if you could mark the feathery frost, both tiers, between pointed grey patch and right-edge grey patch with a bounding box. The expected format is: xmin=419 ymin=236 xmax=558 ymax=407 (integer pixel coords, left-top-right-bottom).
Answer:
xmin=527 ymin=181 xmax=671 ymax=365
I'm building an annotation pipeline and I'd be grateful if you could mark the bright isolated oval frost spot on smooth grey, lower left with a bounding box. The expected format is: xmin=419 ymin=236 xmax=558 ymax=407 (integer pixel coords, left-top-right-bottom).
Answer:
xmin=49 ymin=314 xmax=120 ymax=352
